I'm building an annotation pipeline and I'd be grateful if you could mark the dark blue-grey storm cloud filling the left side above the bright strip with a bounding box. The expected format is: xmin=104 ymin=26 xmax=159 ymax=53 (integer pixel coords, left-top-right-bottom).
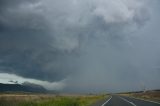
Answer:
xmin=0 ymin=0 xmax=78 ymax=81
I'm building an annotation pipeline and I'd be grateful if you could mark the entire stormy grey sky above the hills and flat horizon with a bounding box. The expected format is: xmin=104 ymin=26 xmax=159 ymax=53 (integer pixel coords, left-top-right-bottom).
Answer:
xmin=0 ymin=0 xmax=160 ymax=93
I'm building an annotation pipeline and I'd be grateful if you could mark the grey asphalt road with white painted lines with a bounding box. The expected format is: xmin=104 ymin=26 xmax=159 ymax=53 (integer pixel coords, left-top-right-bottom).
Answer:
xmin=99 ymin=95 xmax=160 ymax=106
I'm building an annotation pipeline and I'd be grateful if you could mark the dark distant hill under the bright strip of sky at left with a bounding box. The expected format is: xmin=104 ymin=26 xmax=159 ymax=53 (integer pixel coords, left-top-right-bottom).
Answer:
xmin=0 ymin=82 xmax=47 ymax=93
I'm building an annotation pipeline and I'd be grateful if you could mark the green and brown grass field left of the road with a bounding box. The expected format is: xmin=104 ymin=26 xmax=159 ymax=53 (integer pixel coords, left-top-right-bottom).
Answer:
xmin=0 ymin=95 xmax=106 ymax=106
